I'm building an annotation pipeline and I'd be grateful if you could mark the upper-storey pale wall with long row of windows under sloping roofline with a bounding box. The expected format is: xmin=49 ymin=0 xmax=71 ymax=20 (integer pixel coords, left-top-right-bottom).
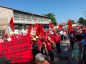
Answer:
xmin=14 ymin=11 xmax=51 ymax=24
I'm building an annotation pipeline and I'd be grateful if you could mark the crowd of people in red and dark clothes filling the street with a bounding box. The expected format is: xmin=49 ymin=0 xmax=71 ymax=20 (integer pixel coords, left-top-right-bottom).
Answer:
xmin=0 ymin=24 xmax=86 ymax=64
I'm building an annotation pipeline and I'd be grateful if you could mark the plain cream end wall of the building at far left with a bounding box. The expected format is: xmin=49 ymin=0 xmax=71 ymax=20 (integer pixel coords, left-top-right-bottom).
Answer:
xmin=0 ymin=7 xmax=13 ymax=33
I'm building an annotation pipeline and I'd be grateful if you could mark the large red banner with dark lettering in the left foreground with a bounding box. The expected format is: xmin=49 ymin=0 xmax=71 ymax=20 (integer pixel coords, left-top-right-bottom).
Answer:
xmin=0 ymin=36 xmax=33 ymax=63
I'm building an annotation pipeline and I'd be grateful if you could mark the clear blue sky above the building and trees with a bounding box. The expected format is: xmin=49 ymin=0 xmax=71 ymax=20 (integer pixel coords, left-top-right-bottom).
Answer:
xmin=0 ymin=0 xmax=86 ymax=23
